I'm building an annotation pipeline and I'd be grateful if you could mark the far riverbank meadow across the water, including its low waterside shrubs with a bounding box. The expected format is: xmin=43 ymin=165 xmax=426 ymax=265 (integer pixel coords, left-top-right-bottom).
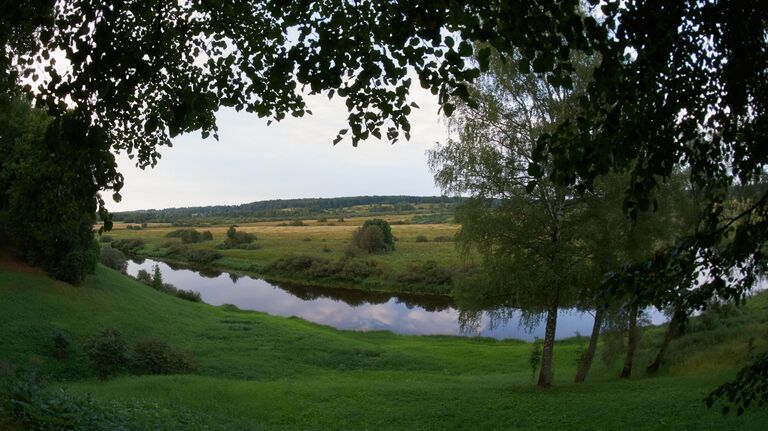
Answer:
xmin=106 ymin=215 xmax=471 ymax=295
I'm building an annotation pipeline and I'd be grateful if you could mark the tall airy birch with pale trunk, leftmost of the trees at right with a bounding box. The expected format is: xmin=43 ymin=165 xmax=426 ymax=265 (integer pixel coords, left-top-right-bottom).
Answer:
xmin=429 ymin=49 xmax=591 ymax=387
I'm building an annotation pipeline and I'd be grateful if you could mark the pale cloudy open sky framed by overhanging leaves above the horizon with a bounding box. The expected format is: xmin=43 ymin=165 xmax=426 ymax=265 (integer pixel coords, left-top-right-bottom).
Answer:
xmin=113 ymin=86 xmax=448 ymax=211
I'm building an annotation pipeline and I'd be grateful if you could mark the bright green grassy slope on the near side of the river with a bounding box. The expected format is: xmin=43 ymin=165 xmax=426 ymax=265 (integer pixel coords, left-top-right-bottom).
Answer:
xmin=0 ymin=267 xmax=768 ymax=430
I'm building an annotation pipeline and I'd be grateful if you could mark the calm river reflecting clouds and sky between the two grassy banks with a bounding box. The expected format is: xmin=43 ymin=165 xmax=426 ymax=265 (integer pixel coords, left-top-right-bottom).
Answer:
xmin=128 ymin=259 xmax=665 ymax=340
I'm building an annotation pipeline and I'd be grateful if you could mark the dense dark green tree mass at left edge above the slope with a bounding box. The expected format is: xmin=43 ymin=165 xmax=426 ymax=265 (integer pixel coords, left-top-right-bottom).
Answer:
xmin=0 ymin=98 xmax=112 ymax=283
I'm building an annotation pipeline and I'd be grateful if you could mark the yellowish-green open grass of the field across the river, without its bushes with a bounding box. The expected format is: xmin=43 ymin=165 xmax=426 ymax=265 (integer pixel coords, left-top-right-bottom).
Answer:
xmin=106 ymin=215 xmax=471 ymax=294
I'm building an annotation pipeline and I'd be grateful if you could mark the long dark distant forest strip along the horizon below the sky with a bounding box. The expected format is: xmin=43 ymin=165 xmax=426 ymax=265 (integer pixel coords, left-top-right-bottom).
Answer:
xmin=113 ymin=196 xmax=462 ymax=223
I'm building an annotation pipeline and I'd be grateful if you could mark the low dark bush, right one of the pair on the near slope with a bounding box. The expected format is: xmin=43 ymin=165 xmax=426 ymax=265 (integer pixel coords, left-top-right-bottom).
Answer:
xmin=131 ymin=340 xmax=197 ymax=374
